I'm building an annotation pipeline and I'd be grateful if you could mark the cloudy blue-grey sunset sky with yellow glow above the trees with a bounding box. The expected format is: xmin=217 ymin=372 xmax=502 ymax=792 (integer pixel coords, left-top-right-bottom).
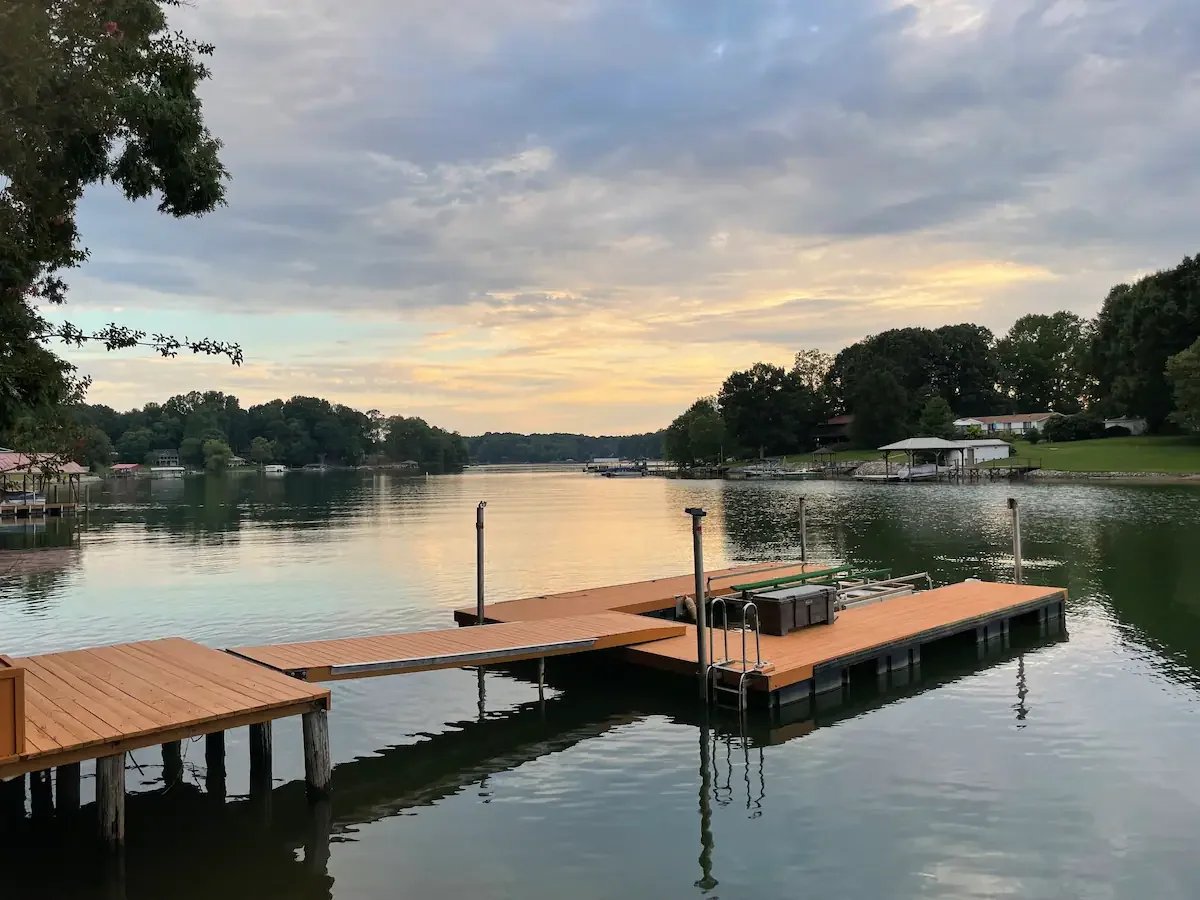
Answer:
xmin=51 ymin=0 xmax=1200 ymax=433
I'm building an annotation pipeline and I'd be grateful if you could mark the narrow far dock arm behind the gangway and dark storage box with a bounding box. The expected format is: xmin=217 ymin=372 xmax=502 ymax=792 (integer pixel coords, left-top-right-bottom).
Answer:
xmin=454 ymin=563 xmax=829 ymax=625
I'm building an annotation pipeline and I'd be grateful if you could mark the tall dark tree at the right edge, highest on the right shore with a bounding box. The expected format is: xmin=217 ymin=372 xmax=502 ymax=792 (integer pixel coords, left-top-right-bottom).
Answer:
xmin=1091 ymin=256 xmax=1200 ymax=431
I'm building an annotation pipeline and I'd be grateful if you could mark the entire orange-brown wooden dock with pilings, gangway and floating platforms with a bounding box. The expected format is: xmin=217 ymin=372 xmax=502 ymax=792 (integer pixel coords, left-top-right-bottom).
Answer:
xmin=0 ymin=563 xmax=1067 ymax=845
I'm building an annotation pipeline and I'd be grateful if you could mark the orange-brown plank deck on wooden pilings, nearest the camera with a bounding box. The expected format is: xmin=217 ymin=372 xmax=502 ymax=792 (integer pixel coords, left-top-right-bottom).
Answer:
xmin=0 ymin=637 xmax=329 ymax=778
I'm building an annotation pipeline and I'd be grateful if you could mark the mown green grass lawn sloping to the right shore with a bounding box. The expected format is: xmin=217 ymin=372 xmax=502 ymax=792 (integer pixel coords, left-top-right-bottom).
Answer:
xmin=1015 ymin=436 xmax=1200 ymax=474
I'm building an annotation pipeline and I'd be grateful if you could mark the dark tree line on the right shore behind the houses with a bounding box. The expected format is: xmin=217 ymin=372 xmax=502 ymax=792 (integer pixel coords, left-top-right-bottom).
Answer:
xmin=666 ymin=256 xmax=1200 ymax=464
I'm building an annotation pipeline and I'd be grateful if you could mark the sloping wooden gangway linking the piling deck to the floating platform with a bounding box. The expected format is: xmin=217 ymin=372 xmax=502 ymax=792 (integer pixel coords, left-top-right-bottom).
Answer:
xmin=229 ymin=612 xmax=685 ymax=682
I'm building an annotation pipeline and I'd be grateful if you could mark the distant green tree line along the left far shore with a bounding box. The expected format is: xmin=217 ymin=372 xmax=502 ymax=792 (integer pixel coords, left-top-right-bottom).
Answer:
xmin=49 ymin=391 xmax=467 ymax=474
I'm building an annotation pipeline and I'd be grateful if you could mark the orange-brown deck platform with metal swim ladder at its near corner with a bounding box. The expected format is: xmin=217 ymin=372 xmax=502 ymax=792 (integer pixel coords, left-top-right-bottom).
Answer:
xmin=624 ymin=581 xmax=1066 ymax=690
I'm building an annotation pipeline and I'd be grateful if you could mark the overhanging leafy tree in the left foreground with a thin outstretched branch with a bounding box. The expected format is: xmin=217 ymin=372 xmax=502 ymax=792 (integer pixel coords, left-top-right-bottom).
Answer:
xmin=0 ymin=0 xmax=241 ymax=430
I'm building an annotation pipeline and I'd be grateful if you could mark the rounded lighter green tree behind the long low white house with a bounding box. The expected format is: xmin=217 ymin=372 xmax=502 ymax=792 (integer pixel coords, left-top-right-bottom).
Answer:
xmin=996 ymin=311 xmax=1091 ymax=414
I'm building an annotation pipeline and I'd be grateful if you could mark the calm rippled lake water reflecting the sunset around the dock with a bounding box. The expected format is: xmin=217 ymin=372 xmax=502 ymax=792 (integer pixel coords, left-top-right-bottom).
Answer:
xmin=0 ymin=472 xmax=1200 ymax=900
